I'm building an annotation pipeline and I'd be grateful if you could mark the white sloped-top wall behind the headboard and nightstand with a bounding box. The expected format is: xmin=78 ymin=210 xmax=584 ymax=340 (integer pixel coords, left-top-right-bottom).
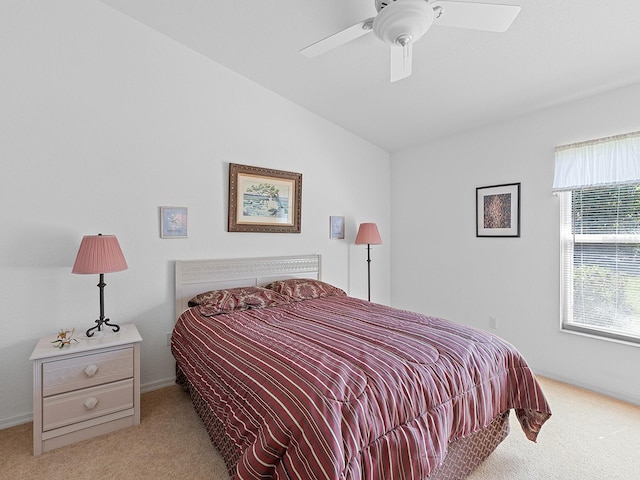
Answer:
xmin=0 ymin=0 xmax=390 ymax=427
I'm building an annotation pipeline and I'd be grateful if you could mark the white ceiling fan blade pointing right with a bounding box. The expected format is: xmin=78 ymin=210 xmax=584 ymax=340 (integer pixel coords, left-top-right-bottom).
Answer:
xmin=431 ymin=0 xmax=520 ymax=32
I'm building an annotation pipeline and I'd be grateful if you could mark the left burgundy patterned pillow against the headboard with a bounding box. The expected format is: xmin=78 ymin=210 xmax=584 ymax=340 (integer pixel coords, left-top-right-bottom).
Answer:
xmin=189 ymin=287 xmax=293 ymax=316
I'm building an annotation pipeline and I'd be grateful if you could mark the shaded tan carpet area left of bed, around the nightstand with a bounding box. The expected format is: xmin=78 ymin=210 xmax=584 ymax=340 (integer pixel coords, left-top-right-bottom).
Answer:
xmin=0 ymin=386 xmax=228 ymax=480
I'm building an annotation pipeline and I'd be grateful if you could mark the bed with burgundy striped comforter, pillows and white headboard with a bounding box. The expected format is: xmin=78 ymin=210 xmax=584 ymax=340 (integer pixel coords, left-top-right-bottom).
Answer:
xmin=171 ymin=255 xmax=551 ymax=480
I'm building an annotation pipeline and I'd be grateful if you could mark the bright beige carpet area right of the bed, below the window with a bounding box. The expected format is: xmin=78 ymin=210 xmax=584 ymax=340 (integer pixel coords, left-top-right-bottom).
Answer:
xmin=468 ymin=378 xmax=640 ymax=480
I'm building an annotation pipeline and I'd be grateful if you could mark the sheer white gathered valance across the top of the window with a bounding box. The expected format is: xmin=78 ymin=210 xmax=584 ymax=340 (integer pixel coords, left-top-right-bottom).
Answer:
xmin=553 ymin=132 xmax=640 ymax=192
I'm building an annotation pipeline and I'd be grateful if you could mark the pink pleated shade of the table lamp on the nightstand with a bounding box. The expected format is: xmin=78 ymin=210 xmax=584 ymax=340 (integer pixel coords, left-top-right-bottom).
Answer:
xmin=71 ymin=235 xmax=128 ymax=274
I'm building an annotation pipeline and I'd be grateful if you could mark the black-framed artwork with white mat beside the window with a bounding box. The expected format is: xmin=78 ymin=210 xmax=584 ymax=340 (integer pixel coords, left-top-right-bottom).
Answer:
xmin=476 ymin=183 xmax=520 ymax=237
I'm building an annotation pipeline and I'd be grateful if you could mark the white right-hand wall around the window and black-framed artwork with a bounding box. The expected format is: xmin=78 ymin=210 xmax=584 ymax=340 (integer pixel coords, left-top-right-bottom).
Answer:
xmin=391 ymin=85 xmax=640 ymax=404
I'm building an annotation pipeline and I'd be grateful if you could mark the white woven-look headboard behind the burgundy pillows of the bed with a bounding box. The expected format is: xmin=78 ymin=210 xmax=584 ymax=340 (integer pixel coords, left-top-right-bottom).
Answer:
xmin=175 ymin=254 xmax=321 ymax=319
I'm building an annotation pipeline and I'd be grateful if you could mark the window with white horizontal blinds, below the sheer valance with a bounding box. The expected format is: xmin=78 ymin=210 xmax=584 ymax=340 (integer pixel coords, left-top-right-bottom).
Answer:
xmin=561 ymin=184 xmax=640 ymax=341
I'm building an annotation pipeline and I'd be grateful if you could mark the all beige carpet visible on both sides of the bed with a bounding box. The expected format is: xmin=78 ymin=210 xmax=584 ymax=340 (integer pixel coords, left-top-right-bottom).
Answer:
xmin=0 ymin=378 xmax=640 ymax=480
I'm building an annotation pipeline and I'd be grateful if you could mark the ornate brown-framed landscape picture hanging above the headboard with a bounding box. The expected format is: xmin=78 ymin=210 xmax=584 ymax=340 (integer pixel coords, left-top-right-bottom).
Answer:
xmin=228 ymin=163 xmax=302 ymax=233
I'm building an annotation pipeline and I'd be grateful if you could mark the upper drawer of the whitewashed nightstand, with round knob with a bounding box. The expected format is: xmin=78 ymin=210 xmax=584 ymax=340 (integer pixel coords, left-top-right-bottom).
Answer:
xmin=42 ymin=347 xmax=133 ymax=397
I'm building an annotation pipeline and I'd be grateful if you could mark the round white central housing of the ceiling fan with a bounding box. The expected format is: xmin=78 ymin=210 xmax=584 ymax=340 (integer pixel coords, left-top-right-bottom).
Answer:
xmin=373 ymin=0 xmax=434 ymax=46
